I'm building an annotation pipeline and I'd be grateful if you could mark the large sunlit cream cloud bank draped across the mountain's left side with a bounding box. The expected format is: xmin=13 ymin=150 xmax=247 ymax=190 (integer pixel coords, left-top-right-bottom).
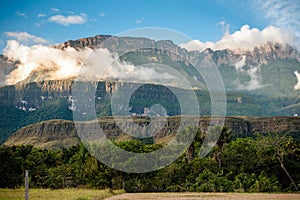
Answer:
xmin=4 ymin=40 xmax=175 ymax=85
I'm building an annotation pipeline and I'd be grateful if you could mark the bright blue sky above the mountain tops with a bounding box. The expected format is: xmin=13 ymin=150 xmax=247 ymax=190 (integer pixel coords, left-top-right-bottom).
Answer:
xmin=0 ymin=0 xmax=300 ymax=52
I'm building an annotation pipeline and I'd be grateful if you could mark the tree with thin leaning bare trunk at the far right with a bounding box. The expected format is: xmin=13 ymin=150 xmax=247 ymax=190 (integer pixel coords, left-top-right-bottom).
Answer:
xmin=256 ymin=133 xmax=298 ymax=190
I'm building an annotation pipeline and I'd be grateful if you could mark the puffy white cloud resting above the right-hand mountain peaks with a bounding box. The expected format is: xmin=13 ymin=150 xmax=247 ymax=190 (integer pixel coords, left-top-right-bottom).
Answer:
xmin=180 ymin=25 xmax=294 ymax=51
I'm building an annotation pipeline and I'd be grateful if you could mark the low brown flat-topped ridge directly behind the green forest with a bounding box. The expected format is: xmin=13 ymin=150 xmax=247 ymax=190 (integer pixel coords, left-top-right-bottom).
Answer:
xmin=4 ymin=116 xmax=300 ymax=149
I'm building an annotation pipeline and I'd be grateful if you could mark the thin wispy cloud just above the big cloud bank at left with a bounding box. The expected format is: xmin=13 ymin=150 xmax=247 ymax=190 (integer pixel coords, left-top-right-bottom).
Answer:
xmin=5 ymin=31 xmax=48 ymax=44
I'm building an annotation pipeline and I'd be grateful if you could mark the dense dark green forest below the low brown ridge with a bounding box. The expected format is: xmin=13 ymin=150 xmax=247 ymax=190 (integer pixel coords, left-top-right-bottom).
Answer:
xmin=0 ymin=127 xmax=300 ymax=192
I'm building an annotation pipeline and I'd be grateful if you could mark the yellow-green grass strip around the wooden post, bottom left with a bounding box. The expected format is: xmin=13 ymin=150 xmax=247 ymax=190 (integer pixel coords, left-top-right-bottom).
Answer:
xmin=0 ymin=188 xmax=124 ymax=200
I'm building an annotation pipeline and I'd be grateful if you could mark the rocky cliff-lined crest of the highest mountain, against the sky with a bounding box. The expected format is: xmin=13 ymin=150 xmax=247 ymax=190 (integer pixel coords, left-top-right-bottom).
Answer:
xmin=58 ymin=35 xmax=300 ymax=65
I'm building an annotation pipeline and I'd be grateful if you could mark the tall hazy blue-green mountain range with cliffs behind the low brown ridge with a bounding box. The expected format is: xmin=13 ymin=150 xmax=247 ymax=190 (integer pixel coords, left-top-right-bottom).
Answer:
xmin=0 ymin=35 xmax=300 ymax=147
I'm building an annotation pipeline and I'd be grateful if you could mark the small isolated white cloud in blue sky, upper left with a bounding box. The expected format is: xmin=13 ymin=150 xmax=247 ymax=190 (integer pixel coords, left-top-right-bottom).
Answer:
xmin=49 ymin=13 xmax=87 ymax=26
